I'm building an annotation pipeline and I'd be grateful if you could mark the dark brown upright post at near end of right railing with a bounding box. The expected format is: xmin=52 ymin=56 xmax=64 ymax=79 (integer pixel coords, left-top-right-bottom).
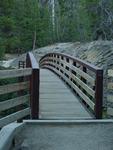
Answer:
xmin=95 ymin=70 xmax=103 ymax=119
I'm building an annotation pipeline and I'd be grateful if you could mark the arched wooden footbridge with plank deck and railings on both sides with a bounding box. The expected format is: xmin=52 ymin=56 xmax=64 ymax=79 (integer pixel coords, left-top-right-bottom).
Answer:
xmin=0 ymin=53 xmax=107 ymax=149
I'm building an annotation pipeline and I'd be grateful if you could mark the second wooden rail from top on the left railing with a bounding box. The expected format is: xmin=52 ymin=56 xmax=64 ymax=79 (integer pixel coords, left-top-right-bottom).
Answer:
xmin=0 ymin=82 xmax=29 ymax=94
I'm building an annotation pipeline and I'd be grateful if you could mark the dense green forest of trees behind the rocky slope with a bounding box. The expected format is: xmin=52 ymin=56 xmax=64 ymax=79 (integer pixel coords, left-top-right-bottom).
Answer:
xmin=0 ymin=0 xmax=113 ymax=58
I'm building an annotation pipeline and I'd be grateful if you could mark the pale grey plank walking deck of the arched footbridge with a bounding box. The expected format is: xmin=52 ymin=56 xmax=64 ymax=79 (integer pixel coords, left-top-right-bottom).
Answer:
xmin=40 ymin=69 xmax=92 ymax=119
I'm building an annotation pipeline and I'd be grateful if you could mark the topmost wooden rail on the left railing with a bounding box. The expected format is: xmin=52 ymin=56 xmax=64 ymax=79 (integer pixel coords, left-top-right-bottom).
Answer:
xmin=0 ymin=68 xmax=32 ymax=79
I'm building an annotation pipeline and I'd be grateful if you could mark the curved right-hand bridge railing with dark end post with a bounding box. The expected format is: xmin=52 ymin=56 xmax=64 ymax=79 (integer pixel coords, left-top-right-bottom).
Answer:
xmin=40 ymin=53 xmax=103 ymax=119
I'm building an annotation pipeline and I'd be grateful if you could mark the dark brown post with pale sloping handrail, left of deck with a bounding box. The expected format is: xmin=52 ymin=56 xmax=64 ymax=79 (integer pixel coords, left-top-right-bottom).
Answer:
xmin=26 ymin=53 xmax=40 ymax=119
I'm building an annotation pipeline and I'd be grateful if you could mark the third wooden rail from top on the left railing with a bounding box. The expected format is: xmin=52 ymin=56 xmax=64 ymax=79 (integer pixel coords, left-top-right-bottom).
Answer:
xmin=0 ymin=95 xmax=30 ymax=111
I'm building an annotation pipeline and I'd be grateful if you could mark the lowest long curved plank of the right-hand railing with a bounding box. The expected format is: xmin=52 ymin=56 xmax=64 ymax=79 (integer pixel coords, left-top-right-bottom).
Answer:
xmin=44 ymin=66 xmax=95 ymax=110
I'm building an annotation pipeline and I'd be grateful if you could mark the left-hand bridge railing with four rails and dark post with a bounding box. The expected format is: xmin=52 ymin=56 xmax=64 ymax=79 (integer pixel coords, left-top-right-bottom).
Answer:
xmin=0 ymin=53 xmax=39 ymax=128
